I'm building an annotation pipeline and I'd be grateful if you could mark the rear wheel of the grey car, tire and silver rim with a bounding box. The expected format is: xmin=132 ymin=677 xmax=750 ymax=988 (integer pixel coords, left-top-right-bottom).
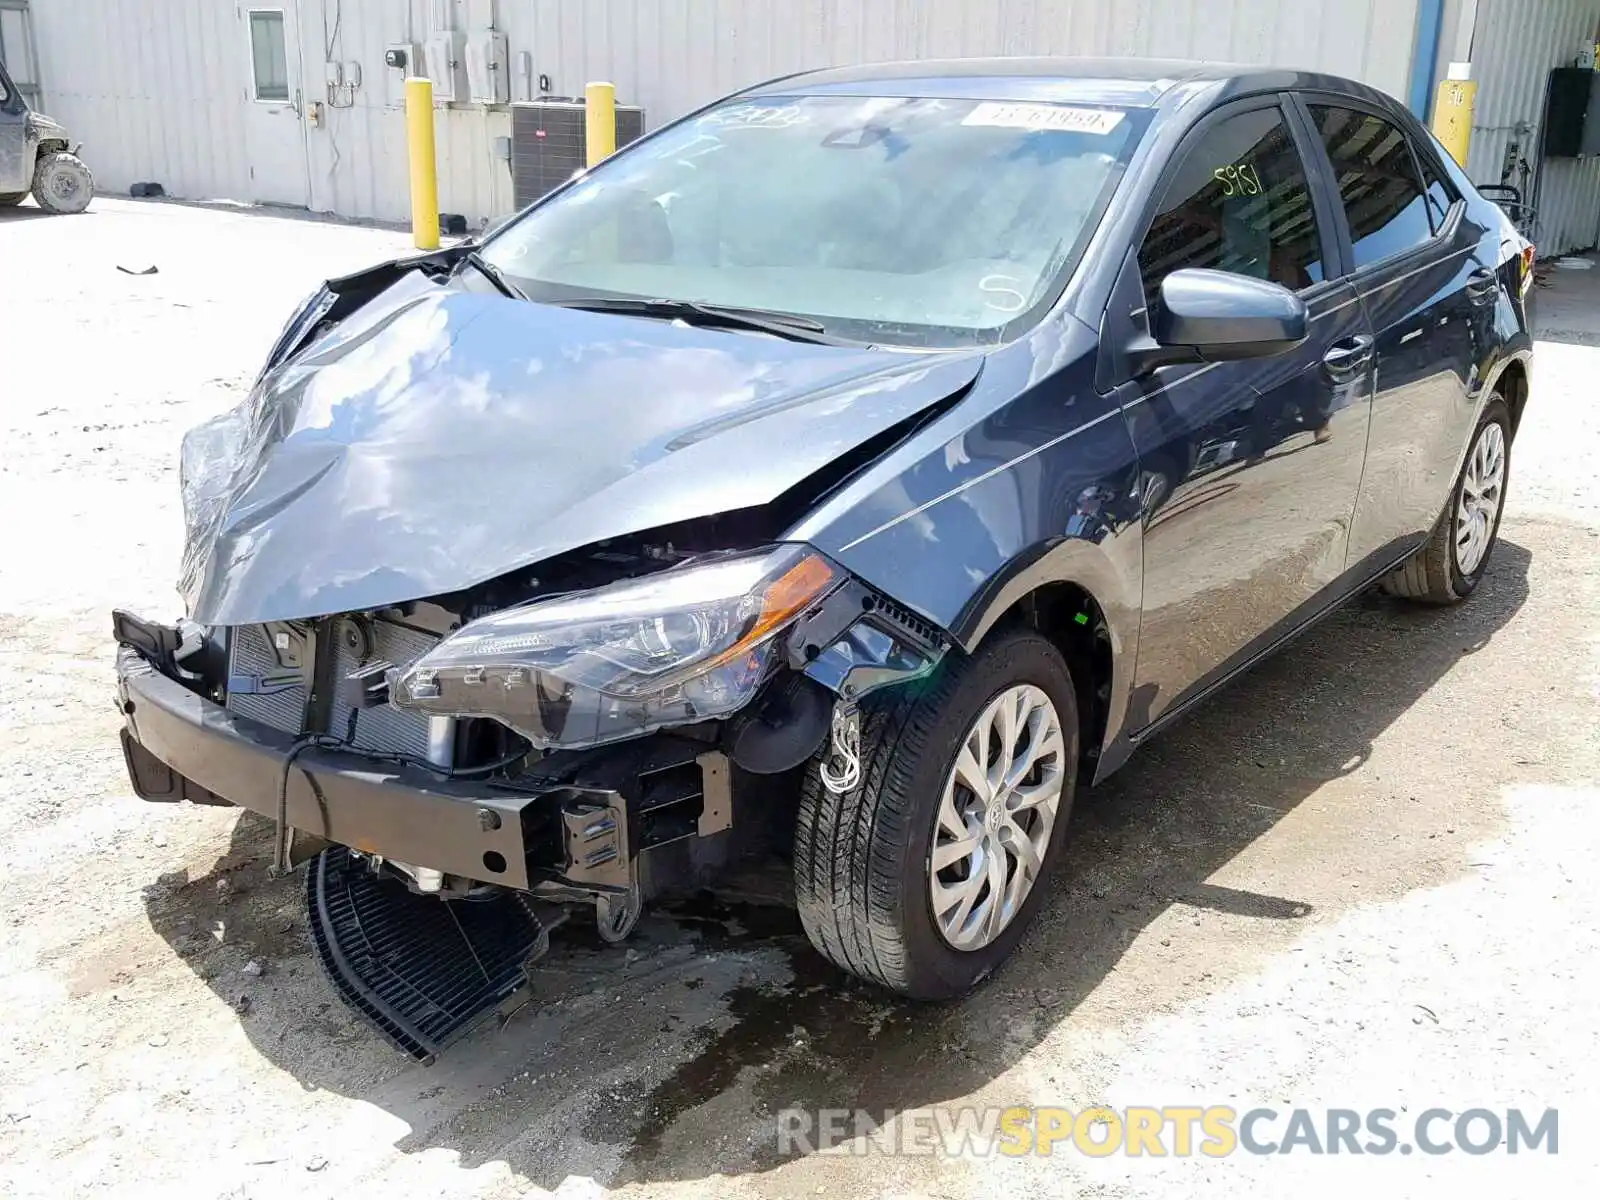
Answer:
xmin=1382 ymin=395 xmax=1510 ymax=605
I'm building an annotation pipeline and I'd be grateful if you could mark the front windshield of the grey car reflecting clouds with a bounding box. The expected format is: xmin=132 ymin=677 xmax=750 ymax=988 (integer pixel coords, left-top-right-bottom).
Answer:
xmin=483 ymin=96 xmax=1149 ymax=347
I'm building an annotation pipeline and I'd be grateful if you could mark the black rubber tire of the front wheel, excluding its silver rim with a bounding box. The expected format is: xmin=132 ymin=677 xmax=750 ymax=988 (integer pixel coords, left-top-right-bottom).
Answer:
xmin=794 ymin=629 xmax=1078 ymax=1000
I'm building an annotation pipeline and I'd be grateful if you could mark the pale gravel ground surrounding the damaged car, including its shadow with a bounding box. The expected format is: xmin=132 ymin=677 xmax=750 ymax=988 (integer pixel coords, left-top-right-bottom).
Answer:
xmin=0 ymin=200 xmax=1600 ymax=1198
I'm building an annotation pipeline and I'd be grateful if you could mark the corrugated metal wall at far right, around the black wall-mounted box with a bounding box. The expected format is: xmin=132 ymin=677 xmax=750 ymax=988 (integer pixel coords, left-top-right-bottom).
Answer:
xmin=1467 ymin=0 xmax=1600 ymax=254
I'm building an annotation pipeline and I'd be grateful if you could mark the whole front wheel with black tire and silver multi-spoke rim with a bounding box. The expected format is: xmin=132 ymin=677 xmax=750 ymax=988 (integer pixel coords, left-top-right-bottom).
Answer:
xmin=795 ymin=629 xmax=1078 ymax=1000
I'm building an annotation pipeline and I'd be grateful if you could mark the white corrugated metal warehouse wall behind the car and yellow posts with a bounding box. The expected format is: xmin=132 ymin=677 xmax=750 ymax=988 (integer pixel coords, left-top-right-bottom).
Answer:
xmin=34 ymin=0 xmax=1418 ymax=221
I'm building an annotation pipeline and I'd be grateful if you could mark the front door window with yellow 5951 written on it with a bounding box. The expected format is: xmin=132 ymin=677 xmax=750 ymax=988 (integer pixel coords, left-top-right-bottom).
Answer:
xmin=1139 ymin=106 xmax=1323 ymax=306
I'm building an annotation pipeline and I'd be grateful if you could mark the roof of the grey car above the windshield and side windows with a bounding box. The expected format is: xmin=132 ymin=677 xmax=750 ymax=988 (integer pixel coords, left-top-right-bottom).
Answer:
xmin=744 ymin=58 xmax=1370 ymax=106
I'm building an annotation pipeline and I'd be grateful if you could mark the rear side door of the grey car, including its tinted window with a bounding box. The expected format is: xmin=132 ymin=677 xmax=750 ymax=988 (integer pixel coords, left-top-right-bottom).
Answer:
xmin=1301 ymin=94 xmax=1496 ymax=571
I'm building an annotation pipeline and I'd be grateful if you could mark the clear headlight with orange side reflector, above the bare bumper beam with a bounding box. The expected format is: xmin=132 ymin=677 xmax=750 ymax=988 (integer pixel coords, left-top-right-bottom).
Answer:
xmin=389 ymin=546 xmax=845 ymax=749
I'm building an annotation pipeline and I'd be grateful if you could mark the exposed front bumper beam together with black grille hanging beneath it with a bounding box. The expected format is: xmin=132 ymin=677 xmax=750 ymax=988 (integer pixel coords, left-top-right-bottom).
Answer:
xmin=117 ymin=640 xmax=731 ymax=1062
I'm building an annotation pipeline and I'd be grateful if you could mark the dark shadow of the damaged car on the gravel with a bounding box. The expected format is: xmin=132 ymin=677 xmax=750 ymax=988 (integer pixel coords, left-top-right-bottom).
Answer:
xmin=147 ymin=541 xmax=1531 ymax=1187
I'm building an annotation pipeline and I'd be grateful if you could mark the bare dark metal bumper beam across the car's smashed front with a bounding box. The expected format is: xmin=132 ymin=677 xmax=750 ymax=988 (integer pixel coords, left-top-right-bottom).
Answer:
xmin=117 ymin=646 xmax=544 ymax=888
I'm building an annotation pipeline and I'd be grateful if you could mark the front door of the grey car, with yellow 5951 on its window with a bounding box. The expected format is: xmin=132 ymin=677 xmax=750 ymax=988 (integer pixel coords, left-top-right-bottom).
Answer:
xmin=1107 ymin=98 xmax=1371 ymax=730
